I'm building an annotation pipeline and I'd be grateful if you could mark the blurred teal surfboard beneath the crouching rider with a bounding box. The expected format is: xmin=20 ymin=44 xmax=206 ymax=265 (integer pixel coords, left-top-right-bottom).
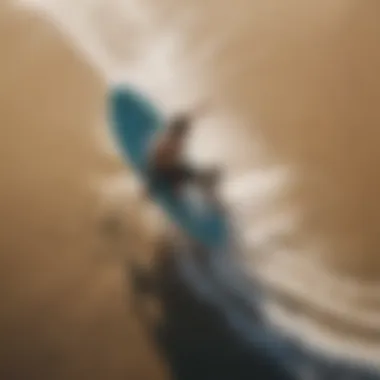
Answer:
xmin=109 ymin=87 xmax=227 ymax=248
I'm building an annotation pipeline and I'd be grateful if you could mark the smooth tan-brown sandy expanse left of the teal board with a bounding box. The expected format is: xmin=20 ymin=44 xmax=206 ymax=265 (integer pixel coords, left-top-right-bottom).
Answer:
xmin=0 ymin=2 xmax=165 ymax=380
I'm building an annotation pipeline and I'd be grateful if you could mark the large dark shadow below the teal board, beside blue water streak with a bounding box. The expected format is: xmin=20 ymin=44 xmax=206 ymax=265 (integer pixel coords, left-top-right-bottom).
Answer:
xmin=126 ymin=238 xmax=293 ymax=380
